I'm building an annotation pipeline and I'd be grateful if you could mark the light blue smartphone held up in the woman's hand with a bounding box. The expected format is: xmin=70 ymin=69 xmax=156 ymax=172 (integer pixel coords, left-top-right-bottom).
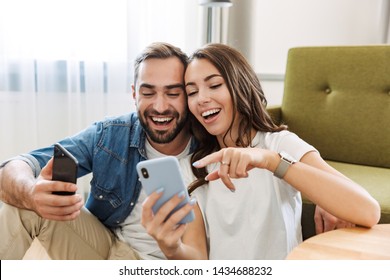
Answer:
xmin=137 ymin=156 xmax=195 ymax=224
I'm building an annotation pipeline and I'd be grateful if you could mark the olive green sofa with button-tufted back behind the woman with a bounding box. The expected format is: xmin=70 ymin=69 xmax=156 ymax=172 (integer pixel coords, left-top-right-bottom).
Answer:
xmin=267 ymin=45 xmax=390 ymax=239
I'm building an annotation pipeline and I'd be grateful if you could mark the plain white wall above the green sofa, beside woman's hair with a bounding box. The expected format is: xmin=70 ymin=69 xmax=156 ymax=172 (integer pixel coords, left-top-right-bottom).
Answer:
xmin=228 ymin=0 xmax=389 ymax=104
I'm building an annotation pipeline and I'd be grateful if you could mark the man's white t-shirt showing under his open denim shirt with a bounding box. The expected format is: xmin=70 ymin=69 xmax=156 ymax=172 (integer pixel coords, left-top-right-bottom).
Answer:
xmin=115 ymin=140 xmax=191 ymax=260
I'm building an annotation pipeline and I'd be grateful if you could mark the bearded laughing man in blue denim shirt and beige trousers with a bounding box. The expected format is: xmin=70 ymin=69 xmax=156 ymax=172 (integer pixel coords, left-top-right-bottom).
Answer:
xmin=0 ymin=43 xmax=191 ymax=259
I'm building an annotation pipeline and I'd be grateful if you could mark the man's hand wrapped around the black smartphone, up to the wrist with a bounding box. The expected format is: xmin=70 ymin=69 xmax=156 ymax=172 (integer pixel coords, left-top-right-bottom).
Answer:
xmin=31 ymin=159 xmax=84 ymax=221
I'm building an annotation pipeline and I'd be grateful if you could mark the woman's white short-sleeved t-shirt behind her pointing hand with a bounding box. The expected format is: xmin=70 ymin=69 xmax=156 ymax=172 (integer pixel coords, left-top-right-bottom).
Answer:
xmin=180 ymin=131 xmax=315 ymax=260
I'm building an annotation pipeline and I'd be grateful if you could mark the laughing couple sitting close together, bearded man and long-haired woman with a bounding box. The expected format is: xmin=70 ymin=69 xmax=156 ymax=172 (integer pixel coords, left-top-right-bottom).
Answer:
xmin=0 ymin=43 xmax=380 ymax=259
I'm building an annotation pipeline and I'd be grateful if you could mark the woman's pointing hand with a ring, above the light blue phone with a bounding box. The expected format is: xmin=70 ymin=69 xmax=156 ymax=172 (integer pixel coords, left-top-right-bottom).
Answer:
xmin=193 ymin=148 xmax=277 ymax=191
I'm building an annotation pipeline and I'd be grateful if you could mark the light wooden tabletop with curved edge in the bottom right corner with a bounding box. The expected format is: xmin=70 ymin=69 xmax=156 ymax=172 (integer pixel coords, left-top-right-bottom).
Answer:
xmin=287 ymin=224 xmax=390 ymax=260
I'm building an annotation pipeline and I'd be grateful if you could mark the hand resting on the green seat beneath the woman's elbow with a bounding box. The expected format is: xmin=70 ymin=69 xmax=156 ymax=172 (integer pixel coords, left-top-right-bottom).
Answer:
xmin=314 ymin=205 xmax=355 ymax=234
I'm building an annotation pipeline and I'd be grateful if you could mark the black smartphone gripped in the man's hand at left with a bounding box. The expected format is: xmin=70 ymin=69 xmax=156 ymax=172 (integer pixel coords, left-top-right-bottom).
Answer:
xmin=52 ymin=143 xmax=78 ymax=195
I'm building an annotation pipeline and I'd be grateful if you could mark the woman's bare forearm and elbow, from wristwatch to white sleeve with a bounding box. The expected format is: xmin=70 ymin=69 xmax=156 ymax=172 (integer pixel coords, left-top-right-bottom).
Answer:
xmin=283 ymin=152 xmax=380 ymax=227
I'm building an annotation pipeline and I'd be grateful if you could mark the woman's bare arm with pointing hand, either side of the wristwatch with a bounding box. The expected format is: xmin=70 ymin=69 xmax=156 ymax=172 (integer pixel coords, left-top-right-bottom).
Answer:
xmin=194 ymin=148 xmax=380 ymax=227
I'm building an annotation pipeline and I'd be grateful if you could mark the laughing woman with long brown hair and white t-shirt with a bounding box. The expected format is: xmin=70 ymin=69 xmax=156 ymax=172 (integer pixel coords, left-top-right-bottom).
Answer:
xmin=143 ymin=44 xmax=380 ymax=259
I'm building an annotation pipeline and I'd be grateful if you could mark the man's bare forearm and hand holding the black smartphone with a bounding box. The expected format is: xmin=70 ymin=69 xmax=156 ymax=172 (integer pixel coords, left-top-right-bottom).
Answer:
xmin=0 ymin=160 xmax=84 ymax=221
